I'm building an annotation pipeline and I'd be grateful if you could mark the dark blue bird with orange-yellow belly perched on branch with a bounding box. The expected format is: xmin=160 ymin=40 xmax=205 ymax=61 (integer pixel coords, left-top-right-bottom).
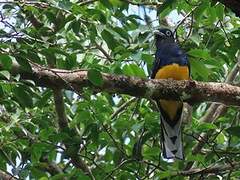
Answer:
xmin=151 ymin=28 xmax=190 ymax=160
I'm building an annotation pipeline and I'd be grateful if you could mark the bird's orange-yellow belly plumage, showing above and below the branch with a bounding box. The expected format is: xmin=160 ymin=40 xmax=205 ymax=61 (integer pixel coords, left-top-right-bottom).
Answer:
xmin=155 ymin=64 xmax=189 ymax=120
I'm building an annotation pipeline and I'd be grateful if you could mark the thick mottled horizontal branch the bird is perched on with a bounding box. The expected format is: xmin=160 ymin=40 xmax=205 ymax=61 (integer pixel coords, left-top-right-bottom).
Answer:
xmin=10 ymin=65 xmax=240 ymax=105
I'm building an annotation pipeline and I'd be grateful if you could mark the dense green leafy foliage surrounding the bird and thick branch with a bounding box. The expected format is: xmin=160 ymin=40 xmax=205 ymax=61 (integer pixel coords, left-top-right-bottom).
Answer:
xmin=0 ymin=0 xmax=240 ymax=179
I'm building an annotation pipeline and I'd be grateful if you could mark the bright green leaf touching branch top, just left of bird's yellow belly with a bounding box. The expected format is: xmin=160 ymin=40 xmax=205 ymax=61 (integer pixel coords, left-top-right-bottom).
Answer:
xmin=123 ymin=64 xmax=146 ymax=78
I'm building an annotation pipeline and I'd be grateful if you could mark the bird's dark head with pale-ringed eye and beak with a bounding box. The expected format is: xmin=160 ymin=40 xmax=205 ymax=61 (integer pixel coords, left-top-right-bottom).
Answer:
xmin=154 ymin=28 xmax=174 ymax=47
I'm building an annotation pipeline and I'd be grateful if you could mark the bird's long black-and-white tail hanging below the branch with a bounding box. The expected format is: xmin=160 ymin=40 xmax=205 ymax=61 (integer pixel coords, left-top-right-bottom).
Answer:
xmin=161 ymin=112 xmax=184 ymax=159
